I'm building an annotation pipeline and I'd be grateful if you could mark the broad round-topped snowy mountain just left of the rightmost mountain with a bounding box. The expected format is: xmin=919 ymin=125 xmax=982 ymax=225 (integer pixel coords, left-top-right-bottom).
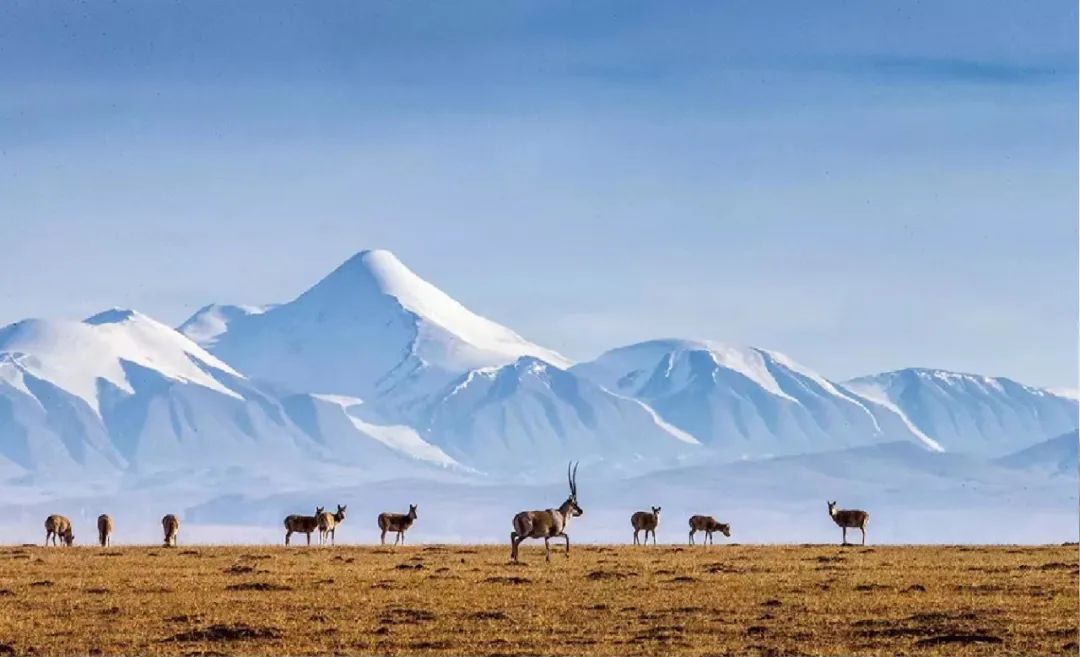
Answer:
xmin=571 ymin=339 xmax=920 ymax=458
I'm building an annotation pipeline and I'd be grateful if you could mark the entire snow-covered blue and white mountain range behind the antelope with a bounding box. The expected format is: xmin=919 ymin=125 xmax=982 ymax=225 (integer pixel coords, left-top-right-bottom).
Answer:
xmin=0 ymin=251 xmax=1078 ymax=486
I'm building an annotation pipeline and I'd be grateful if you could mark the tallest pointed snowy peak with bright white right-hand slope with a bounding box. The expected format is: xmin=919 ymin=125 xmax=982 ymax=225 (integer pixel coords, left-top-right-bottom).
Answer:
xmin=199 ymin=251 xmax=568 ymax=408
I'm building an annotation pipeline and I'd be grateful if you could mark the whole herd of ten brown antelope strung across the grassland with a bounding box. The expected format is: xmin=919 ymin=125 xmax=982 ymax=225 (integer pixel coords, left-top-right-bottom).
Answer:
xmin=38 ymin=464 xmax=870 ymax=562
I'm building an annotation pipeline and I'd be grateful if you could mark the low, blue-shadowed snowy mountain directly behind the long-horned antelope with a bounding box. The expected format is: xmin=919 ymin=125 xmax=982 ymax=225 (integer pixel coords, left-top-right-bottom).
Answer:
xmin=421 ymin=357 xmax=700 ymax=474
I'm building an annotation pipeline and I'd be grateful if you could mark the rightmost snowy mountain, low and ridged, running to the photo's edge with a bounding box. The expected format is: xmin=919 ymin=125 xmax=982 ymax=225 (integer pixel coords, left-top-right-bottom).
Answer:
xmin=843 ymin=368 xmax=1080 ymax=456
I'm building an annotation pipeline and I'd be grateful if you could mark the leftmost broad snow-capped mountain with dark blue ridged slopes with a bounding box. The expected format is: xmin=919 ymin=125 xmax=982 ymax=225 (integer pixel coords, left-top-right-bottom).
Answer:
xmin=0 ymin=309 xmax=455 ymax=479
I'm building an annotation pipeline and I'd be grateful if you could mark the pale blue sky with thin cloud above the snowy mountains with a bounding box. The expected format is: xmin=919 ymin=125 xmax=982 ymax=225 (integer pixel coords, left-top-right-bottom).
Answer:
xmin=0 ymin=0 xmax=1078 ymax=386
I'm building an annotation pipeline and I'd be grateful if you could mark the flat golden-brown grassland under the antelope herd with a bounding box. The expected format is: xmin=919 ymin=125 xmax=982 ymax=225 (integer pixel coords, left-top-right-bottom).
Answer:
xmin=0 ymin=537 xmax=1078 ymax=655
